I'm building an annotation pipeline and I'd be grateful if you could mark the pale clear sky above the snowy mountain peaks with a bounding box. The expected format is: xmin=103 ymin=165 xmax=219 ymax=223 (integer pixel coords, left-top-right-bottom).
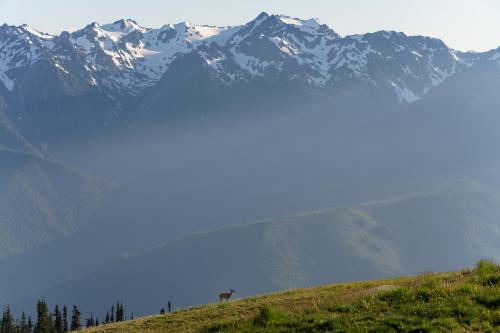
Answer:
xmin=0 ymin=0 xmax=500 ymax=51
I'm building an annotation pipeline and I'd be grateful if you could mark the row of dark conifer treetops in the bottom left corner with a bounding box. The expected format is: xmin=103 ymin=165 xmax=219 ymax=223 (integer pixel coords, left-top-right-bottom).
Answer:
xmin=0 ymin=300 xmax=129 ymax=333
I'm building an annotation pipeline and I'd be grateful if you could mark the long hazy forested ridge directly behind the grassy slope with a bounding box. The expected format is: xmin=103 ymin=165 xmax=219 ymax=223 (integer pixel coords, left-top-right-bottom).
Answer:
xmin=29 ymin=176 xmax=500 ymax=314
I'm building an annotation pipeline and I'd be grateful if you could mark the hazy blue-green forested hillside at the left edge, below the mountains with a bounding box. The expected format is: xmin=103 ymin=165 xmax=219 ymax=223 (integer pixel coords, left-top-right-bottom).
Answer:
xmin=0 ymin=149 xmax=112 ymax=258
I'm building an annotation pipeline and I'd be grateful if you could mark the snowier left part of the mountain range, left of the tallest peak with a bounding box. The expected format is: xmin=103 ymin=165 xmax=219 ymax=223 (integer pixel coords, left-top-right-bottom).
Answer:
xmin=0 ymin=20 xmax=238 ymax=95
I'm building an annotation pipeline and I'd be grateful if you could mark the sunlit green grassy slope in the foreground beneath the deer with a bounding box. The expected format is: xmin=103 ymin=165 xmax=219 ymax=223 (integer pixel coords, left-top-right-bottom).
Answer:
xmin=86 ymin=261 xmax=500 ymax=333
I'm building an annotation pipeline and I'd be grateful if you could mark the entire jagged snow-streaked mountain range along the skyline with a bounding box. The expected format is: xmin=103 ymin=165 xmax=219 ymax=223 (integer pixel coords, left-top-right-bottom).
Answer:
xmin=0 ymin=13 xmax=494 ymax=102
